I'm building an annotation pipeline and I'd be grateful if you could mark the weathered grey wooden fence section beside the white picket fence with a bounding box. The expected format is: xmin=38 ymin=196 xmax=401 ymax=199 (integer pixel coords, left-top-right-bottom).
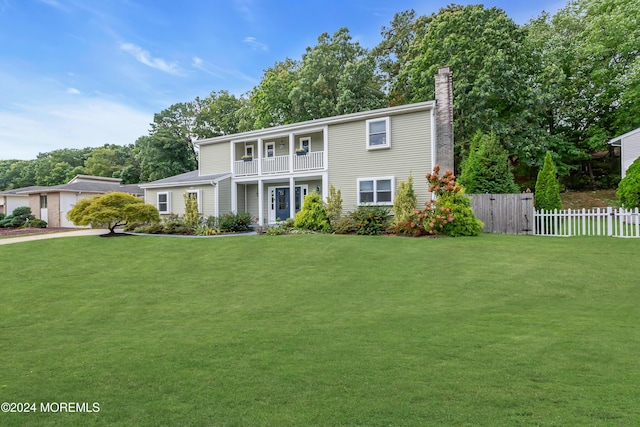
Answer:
xmin=467 ymin=193 xmax=533 ymax=234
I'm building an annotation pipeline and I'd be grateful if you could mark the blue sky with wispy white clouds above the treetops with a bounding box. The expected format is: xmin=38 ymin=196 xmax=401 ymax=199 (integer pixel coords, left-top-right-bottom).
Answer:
xmin=0 ymin=0 xmax=566 ymax=160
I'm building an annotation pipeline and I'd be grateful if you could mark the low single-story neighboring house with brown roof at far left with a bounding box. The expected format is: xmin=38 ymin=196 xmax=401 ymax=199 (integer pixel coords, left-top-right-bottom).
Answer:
xmin=0 ymin=175 xmax=143 ymax=227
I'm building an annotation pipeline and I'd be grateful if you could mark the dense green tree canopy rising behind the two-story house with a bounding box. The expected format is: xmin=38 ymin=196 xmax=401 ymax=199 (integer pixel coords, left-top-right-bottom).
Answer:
xmin=0 ymin=0 xmax=640 ymax=190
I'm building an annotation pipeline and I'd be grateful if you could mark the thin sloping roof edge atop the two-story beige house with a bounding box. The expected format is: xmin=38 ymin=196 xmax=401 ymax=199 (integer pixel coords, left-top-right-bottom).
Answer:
xmin=193 ymin=101 xmax=436 ymax=146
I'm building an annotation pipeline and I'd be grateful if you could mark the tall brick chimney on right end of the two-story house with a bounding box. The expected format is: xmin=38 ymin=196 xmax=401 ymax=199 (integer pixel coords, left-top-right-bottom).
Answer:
xmin=434 ymin=67 xmax=455 ymax=174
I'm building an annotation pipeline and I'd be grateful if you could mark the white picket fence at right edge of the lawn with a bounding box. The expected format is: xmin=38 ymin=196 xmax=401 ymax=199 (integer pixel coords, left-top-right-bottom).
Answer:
xmin=533 ymin=207 xmax=640 ymax=237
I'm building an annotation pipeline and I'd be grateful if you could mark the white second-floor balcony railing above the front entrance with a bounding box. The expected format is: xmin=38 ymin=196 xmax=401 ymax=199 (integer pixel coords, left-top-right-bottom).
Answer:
xmin=233 ymin=151 xmax=325 ymax=176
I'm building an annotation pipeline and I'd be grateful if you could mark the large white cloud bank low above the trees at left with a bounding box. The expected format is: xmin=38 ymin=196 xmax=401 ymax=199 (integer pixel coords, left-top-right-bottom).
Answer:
xmin=0 ymin=98 xmax=153 ymax=160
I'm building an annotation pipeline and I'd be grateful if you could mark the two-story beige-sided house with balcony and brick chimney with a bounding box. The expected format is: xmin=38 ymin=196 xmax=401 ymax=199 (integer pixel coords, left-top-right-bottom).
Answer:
xmin=140 ymin=68 xmax=453 ymax=225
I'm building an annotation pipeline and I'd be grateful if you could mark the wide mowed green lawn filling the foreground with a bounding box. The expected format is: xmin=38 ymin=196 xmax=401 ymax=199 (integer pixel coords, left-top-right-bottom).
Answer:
xmin=0 ymin=235 xmax=640 ymax=426
